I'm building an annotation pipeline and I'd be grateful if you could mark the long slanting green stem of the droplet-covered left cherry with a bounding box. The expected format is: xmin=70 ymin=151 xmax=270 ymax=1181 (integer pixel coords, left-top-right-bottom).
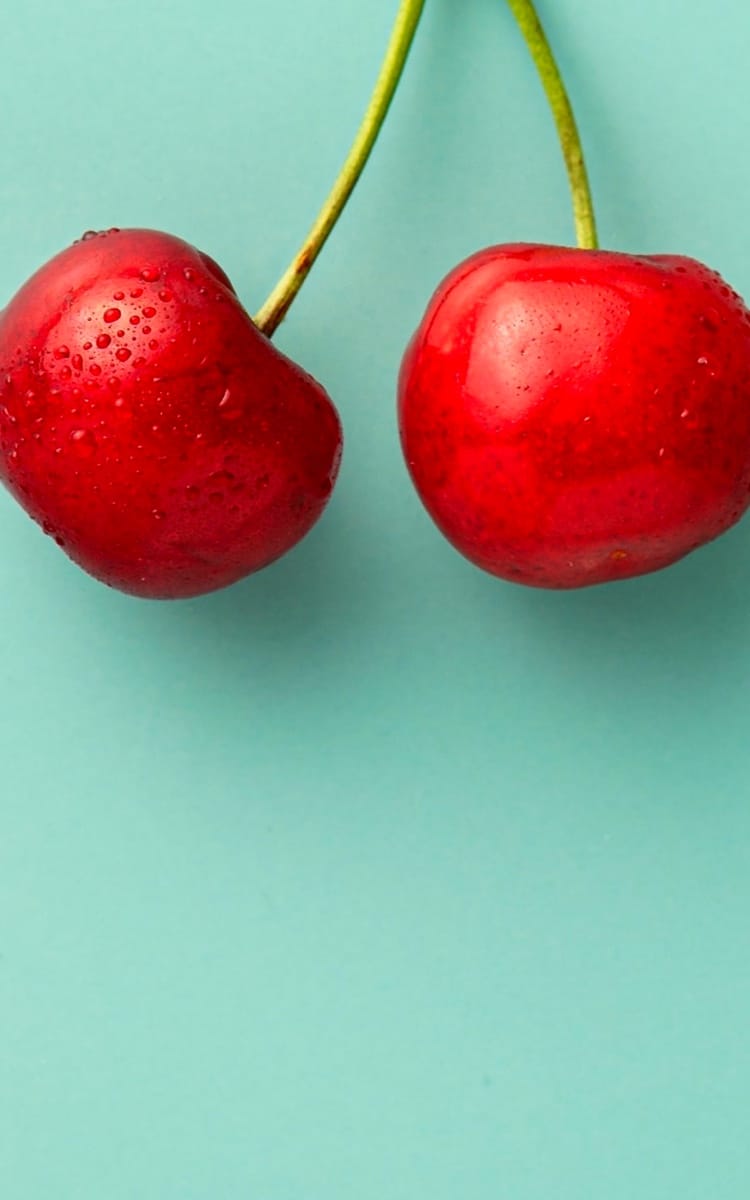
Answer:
xmin=254 ymin=0 xmax=425 ymax=337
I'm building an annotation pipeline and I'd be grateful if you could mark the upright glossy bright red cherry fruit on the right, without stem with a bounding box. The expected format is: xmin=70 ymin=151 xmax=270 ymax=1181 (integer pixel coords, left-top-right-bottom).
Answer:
xmin=398 ymin=245 xmax=750 ymax=588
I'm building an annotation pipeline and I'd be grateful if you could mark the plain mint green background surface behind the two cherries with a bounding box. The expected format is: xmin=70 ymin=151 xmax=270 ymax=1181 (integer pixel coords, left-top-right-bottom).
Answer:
xmin=0 ymin=0 xmax=750 ymax=1200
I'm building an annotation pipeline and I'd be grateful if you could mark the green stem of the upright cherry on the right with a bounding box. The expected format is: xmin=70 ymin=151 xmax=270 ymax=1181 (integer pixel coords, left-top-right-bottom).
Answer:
xmin=508 ymin=0 xmax=599 ymax=250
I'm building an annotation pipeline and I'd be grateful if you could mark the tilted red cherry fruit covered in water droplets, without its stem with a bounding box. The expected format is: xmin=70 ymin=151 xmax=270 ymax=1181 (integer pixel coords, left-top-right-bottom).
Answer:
xmin=0 ymin=229 xmax=342 ymax=599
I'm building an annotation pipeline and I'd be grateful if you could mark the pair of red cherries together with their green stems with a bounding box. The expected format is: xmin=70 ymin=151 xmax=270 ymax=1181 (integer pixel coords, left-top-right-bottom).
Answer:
xmin=0 ymin=0 xmax=750 ymax=598
